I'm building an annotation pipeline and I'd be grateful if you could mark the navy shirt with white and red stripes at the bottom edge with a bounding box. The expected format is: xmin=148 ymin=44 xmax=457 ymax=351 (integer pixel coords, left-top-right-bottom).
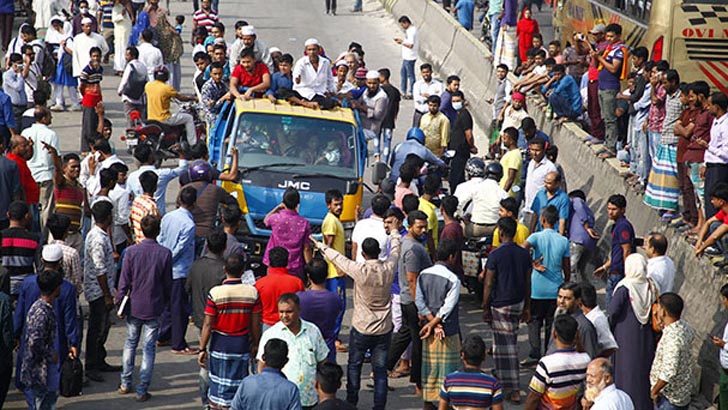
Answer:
xmin=440 ymin=368 xmax=503 ymax=410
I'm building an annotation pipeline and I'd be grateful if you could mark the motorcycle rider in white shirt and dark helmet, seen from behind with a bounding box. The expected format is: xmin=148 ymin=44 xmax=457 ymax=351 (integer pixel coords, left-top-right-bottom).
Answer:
xmin=461 ymin=162 xmax=508 ymax=239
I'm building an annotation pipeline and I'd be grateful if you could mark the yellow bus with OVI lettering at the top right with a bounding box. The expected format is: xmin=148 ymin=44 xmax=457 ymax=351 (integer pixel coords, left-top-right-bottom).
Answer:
xmin=554 ymin=0 xmax=728 ymax=93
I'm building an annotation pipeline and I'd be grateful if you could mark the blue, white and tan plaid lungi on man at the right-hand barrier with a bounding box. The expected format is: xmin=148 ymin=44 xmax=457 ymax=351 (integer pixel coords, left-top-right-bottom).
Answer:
xmin=644 ymin=145 xmax=680 ymax=211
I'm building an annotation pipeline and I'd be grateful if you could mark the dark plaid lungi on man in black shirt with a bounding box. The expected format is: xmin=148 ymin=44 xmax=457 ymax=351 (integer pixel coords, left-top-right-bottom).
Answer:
xmin=490 ymin=302 xmax=523 ymax=393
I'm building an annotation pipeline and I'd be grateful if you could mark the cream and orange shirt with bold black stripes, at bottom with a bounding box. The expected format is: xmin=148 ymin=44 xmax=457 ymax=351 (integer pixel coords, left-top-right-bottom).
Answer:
xmin=528 ymin=348 xmax=591 ymax=410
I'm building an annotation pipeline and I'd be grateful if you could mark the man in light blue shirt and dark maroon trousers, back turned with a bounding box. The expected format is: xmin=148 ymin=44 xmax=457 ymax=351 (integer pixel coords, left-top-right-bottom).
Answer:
xmin=159 ymin=187 xmax=196 ymax=355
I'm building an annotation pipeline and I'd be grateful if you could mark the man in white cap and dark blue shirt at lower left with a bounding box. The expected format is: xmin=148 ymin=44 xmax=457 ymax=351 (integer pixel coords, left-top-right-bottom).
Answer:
xmin=13 ymin=245 xmax=81 ymax=402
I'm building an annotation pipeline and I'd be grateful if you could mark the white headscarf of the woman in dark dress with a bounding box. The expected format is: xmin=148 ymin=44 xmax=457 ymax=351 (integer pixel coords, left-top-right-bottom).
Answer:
xmin=614 ymin=253 xmax=657 ymax=325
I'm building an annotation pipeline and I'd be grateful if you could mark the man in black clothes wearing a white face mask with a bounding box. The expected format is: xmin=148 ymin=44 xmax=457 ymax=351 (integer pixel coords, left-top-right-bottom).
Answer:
xmin=448 ymin=90 xmax=478 ymax=191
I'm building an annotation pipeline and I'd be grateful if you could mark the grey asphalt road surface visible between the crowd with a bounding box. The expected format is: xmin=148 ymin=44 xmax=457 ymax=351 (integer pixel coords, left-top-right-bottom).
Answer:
xmin=4 ymin=0 xmax=550 ymax=410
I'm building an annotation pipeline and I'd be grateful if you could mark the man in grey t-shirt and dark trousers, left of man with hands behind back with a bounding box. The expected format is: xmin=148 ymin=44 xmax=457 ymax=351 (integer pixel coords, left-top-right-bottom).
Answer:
xmin=387 ymin=211 xmax=432 ymax=392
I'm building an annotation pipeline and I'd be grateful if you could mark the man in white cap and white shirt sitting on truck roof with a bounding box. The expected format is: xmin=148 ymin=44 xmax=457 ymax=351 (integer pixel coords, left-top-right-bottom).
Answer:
xmin=293 ymin=38 xmax=336 ymax=109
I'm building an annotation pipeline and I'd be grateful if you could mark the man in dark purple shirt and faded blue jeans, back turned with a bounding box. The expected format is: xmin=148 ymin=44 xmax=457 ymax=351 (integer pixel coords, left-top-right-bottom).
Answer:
xmin=116 ymin=215 xmax=172 ymax=402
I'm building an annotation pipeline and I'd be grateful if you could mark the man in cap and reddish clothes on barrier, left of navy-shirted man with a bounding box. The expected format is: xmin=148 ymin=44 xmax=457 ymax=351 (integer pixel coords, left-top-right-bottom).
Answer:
xmin=576 ymin=24 xmax=608 ymax=141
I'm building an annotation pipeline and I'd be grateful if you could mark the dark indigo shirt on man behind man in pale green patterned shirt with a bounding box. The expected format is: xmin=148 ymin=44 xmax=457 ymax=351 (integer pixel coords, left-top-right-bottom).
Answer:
xmin=296 ymin=290 xmax=341 ymax=363
